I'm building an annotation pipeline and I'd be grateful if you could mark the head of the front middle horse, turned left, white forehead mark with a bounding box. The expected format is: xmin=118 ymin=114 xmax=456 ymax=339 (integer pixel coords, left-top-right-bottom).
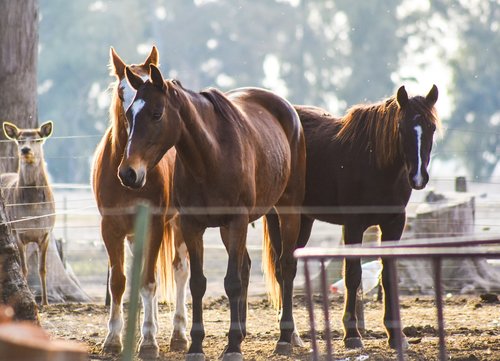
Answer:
xmin=118 ymin=64 xmax=181 ymax=188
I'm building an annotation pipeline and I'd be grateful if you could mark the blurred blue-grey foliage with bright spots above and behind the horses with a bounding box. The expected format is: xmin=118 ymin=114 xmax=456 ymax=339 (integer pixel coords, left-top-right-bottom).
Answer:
xmin=38 ymin=0 xmax=500 ymax=183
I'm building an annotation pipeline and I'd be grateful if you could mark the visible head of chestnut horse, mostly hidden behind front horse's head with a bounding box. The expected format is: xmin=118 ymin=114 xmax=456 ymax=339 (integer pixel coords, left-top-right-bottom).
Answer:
xmin=109 ymin=46 xmax=160 ymax=114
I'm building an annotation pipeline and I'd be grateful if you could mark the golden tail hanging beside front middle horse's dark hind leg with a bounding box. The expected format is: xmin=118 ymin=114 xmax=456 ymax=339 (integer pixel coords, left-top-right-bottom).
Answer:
xmin=262 ymin=217 xmax=281 ymax=309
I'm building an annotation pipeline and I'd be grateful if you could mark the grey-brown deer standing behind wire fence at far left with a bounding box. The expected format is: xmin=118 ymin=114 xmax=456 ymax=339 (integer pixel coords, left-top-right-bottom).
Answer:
xmin=0 ymin=121 xmax=55 ymax=305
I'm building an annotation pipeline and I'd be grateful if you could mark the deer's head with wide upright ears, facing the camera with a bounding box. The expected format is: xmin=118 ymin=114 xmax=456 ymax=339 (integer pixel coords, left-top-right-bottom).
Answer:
xmin=3 ymin=120 xmax=53 ymax=167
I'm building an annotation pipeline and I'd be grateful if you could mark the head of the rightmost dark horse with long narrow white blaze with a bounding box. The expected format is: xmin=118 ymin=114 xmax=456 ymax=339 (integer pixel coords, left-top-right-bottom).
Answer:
xmin=396 ymin=85 xmax=439 ymax=189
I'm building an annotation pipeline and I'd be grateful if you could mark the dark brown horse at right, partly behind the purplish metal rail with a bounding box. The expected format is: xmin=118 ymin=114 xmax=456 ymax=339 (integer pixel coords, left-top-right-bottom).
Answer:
xmin=264 ymin=86 xmax=440 ymax=348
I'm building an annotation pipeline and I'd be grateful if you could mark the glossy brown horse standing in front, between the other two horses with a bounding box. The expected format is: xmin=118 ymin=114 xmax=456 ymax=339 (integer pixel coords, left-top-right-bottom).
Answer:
xmin=119 ymin=65 xmax=305 ymax=360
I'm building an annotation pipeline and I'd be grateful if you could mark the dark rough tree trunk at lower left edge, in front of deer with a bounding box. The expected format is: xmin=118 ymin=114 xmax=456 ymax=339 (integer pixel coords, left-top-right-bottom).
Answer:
xmin=0 ymin=198 xmax=38 ymax=323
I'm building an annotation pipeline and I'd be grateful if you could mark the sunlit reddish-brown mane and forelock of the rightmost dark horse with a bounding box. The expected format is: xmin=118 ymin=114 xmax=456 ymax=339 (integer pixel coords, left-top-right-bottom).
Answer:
xmin=336 ymin=96 xmax=440 ymax=168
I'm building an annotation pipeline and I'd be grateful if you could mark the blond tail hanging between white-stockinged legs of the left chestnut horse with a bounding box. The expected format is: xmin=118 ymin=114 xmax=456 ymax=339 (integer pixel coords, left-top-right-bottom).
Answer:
xmin=156 ymin=221 xmax=175 ymax=303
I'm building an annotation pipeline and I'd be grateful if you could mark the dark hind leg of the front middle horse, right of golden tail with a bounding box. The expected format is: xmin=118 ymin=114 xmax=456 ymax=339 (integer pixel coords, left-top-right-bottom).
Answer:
xmin=275 ymin=208 xmax=307 ymax=354
